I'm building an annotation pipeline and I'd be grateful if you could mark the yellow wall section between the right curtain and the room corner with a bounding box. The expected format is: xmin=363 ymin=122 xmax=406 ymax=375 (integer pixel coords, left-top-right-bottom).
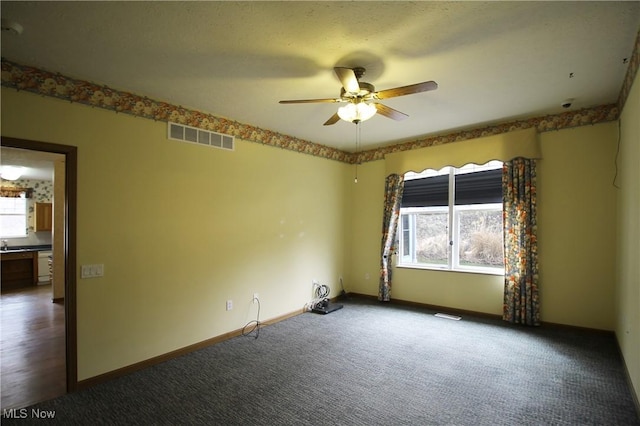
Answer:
xmin=538 ymin=122 xmax=617 ymax=330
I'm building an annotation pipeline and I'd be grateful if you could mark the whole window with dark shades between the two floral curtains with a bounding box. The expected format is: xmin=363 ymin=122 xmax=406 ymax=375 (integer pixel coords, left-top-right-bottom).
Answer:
xmin=398 ymin=161 xmax=504 ymax=274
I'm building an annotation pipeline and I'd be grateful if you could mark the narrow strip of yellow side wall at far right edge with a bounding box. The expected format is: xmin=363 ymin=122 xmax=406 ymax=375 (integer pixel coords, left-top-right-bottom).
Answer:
xmin=615 ymin=69 xmax=640 ymax=400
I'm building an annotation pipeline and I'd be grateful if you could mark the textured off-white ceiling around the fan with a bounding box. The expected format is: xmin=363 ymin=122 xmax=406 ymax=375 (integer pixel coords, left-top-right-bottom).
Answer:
xmin=1 ymin=1 xmax=640 ymax=160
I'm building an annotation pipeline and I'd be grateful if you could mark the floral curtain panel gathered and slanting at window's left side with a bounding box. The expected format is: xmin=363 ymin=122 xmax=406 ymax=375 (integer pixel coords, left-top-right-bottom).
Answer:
xmin=378 ymin=174 xmax=404 ymax=302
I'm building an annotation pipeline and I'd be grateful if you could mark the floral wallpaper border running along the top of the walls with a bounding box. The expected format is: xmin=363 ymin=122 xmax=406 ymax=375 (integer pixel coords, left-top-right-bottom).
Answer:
xmin=0 ymin=32 xmax=640 ymax=164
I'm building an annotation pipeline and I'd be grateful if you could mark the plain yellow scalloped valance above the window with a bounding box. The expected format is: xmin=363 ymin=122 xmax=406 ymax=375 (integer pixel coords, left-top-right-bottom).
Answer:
xmin=385 ymin=127 xmax=542 ymax=176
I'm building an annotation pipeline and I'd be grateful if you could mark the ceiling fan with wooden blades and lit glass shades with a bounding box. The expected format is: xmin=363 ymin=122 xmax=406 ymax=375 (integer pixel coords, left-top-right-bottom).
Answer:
xmin=280 ymin=67 xmax=438 ymax=126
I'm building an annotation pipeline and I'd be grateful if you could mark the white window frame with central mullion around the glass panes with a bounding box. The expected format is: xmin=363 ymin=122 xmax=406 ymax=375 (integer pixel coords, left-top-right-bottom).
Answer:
xmin=397 ymin=165 xmax=504 ymax=275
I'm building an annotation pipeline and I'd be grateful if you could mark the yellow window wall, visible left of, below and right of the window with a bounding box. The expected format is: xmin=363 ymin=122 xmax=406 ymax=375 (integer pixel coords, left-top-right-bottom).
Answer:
xmin=349 ymin=123 xmax=617 ymax=330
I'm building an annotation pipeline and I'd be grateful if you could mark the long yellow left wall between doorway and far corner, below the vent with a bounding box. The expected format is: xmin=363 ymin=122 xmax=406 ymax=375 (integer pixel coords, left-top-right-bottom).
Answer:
xmin=2 ymin=88 xmax=350 ymax=380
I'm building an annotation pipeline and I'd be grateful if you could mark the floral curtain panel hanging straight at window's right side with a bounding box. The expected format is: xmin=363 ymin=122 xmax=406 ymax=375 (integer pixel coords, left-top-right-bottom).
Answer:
xmin=502 ymin=158 xmax=540 ymax=325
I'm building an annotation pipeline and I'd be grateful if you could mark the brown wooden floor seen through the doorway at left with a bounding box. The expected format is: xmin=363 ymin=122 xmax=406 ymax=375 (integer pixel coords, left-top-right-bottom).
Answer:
xmin=0 ymin=285 xmax=66 ymax=409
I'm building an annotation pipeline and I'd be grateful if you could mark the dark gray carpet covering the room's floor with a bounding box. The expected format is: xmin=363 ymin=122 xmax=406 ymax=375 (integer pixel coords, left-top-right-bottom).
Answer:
xmin=2 ymin=299 xmax=640 ymax=425
